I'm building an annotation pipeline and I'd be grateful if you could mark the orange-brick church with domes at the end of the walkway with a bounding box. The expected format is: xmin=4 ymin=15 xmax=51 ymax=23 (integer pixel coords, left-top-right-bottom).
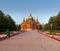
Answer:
xmin=21 ymin=14 xmax=40 ymax=30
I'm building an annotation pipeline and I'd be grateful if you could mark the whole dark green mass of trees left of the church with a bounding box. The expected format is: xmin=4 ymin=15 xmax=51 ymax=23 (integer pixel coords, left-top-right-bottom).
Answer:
xmin=0 ymin=10 xmax=17 ymax=32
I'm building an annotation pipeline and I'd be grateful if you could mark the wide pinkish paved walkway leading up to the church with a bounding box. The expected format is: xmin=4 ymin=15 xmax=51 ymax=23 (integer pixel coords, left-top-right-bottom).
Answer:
xmin=0 ymin=31 xmax=60 ymax=51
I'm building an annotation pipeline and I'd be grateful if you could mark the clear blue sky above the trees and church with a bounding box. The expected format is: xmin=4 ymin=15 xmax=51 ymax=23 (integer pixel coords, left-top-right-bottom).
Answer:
xmin=0 ymin=0 xmax=60 ymax=24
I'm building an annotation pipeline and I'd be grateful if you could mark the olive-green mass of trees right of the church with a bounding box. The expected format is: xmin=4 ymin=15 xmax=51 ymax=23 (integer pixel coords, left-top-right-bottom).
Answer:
xmin=44 ymin=12 xmax=60 ymax=30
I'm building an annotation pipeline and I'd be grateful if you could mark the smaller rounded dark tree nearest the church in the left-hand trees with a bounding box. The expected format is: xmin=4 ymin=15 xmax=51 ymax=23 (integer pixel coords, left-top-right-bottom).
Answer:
xmin=6 ymin=15 xmax=17 ymax=30
